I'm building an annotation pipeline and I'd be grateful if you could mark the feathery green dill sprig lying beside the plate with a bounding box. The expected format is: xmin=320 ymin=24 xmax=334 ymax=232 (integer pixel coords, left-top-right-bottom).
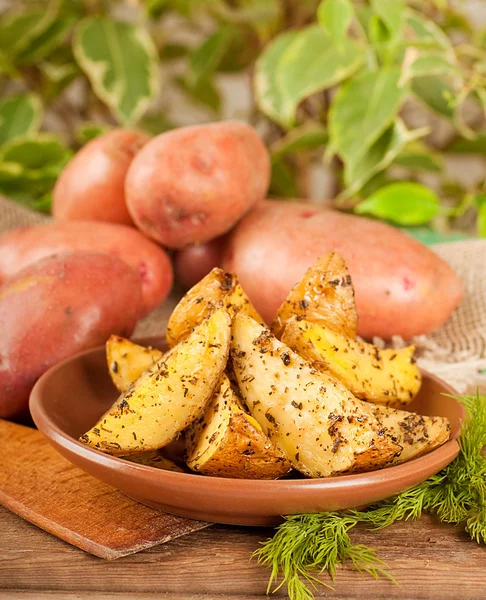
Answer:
xmin=253 ymin=394 xmax=486 ymax=600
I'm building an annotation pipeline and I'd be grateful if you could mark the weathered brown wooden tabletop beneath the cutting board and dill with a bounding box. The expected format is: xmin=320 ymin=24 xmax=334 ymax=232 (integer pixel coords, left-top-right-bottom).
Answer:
xmin=0 ymin=507 xmax=486 ymax=600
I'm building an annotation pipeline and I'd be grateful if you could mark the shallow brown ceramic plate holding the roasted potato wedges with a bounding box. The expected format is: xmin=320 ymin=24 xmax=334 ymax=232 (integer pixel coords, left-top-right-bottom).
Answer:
xmin=30 ymin=338 xmax=464 ymax=525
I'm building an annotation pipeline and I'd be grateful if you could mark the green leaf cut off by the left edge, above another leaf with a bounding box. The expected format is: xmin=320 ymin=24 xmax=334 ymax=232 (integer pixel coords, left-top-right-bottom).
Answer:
xmin=0 ymin=94 xmax=43 ymax=145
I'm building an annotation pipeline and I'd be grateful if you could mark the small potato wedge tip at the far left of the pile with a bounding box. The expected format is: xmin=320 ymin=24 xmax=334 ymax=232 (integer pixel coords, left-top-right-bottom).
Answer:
xmin=106 ymin=335 xmax=164 ymax=392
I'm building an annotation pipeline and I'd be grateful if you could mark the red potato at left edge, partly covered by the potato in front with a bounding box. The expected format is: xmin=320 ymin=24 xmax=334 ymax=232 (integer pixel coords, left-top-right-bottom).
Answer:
xmin=0 ymin=221 xmax=173 ymax=314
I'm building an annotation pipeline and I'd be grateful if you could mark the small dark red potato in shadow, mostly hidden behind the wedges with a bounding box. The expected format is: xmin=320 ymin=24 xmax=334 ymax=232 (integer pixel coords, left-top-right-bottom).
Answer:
xmin=174 ymin=236 xmax=226 ymax=290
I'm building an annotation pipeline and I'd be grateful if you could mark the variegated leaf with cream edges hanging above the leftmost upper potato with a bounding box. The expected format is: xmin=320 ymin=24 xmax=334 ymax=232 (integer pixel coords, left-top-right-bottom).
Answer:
xmin=73 ymin=17 xmax=159 ymax=125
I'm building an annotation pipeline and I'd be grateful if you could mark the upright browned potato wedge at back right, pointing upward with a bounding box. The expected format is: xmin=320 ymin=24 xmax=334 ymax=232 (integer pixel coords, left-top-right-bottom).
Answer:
xmin=272 ymin=252 xmax=358 ymax=339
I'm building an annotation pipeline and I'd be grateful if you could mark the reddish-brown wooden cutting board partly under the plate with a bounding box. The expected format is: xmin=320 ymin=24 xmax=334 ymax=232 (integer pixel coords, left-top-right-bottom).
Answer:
xmin=0 ymin=419 xmax=210 ymax=559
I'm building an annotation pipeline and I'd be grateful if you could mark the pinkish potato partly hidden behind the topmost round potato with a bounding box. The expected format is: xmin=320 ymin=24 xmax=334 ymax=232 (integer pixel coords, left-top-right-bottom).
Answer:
xmin=52 ymin=129 xmax=149 ymax=225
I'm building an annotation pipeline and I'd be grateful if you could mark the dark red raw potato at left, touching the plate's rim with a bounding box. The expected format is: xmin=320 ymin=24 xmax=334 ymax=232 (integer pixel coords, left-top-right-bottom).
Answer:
xmin=0 ymin=252 xmax=142 ymax=418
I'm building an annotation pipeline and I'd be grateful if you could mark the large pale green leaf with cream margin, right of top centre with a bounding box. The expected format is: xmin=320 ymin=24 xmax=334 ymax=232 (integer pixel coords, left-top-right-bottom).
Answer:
xmin=255 ymin=25 xmax=364 ymax=127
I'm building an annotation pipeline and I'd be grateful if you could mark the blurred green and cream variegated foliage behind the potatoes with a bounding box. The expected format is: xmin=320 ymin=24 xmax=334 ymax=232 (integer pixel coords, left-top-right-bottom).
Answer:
xmin=0 ymin=0 xmax=486 ymax=238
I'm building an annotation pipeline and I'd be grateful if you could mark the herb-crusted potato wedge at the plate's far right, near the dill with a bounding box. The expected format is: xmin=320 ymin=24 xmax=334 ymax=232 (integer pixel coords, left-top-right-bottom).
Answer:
xmin=372 ymin=405 xmax=451 ymax=465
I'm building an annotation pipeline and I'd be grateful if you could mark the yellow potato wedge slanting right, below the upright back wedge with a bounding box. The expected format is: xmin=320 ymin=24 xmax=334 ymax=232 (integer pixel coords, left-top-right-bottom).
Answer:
xmin=282 ymin=318 xmax=422 ymax=407
